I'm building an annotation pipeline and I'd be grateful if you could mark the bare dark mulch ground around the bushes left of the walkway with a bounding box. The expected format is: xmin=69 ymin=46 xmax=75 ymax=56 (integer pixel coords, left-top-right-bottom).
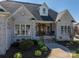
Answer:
xmin=0 ymin=42 xmax=50 ymax=58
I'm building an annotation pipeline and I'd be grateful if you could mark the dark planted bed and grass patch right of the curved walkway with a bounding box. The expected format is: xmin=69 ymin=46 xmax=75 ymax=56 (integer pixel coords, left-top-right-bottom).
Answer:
xmin=56 ymin=41 xmax=79 ymax=58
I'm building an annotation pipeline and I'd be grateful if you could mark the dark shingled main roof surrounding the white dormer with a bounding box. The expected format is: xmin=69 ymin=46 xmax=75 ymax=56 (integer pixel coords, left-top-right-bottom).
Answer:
xmin=0 ymin=1 xmax=58 ymax=21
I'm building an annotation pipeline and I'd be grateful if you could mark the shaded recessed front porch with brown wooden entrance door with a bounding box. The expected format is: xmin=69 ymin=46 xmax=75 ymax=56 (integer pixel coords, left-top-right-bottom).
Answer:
xmin=36 ymin=23 xmax=55 ymax=36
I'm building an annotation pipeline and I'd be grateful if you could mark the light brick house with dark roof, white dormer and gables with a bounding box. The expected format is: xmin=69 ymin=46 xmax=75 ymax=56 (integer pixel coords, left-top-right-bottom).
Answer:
xmin=0 ymin=1 xmax=74 ymax=54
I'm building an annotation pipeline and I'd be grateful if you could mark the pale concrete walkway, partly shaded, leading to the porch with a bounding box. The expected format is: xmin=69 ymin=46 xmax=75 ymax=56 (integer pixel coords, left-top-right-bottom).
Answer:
xmin=46 ymin=43 xmax=72 ymax=58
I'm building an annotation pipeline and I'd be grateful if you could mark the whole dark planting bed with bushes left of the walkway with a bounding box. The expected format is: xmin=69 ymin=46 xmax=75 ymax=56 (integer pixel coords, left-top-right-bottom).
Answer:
xmin=0 ymin=40 xmax=50 ymax=58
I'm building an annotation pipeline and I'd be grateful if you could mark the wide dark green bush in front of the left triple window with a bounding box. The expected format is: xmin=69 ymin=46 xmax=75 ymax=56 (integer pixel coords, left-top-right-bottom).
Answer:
xmin=19 ymin=40 xmax=34 ymax=50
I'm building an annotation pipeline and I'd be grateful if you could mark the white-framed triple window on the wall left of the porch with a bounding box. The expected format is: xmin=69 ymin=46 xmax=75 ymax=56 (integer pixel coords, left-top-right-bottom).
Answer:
xmin=15 ymin=24 xmax=30 ymax=35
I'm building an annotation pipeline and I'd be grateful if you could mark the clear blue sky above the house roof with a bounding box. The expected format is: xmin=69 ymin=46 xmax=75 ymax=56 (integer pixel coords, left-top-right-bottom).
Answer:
xmin=0 ymin=0 xmax=79 ymax=22
